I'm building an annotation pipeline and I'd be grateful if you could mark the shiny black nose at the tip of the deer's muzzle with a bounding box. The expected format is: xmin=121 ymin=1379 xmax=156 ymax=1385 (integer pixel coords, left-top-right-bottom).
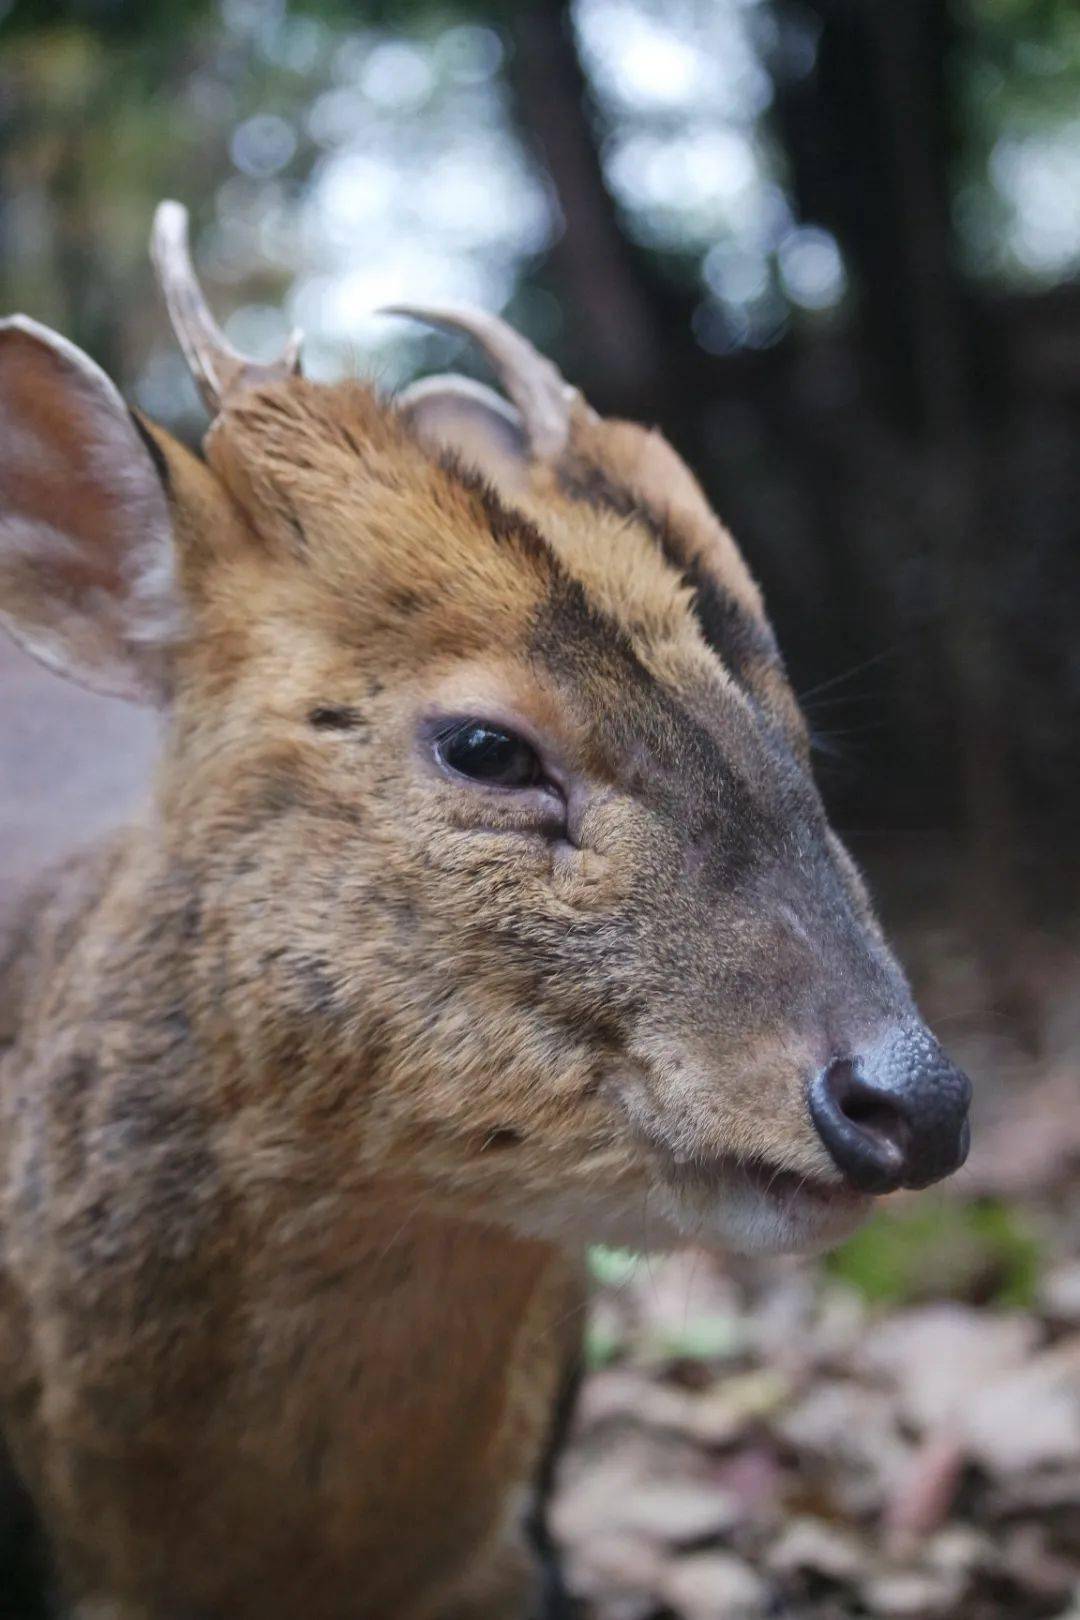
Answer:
xmin=810 ymin=1029 xmax=972 ymax=1192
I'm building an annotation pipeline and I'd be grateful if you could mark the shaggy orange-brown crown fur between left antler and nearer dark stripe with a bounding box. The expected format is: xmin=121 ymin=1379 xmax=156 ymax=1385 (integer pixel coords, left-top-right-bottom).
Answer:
xmin=196 ymin=377 xmax=582 ymax=651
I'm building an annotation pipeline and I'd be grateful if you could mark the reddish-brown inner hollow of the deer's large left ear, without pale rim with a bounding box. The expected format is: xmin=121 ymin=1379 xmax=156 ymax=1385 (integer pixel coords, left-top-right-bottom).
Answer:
xmin=0 ymin=334 xmax=123 ymax=596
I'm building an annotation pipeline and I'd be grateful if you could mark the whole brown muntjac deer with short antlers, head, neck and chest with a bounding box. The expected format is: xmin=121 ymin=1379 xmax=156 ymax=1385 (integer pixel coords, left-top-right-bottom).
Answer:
xmin=0 ymin=204 xmax=968 ymax=1620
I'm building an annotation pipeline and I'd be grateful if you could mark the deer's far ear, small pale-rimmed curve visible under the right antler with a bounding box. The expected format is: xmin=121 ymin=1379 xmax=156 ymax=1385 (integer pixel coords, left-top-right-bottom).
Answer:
xmin=395 ymin=376 xmax=529 ymax=496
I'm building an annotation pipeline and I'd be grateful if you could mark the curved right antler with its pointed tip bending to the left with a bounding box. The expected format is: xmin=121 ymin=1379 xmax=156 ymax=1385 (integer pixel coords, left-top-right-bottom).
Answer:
xmin=379 ymin=305 xmax=581 ymax=460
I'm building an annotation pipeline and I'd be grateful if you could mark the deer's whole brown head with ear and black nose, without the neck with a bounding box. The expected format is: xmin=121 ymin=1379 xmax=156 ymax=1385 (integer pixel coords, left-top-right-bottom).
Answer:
xmin=0 ymin=208 xmax=968 ymax=1249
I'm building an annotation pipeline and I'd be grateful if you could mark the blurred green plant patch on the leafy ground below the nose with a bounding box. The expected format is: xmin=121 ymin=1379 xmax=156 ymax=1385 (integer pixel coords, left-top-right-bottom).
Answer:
xmin=826 ymin=1197 xmax=1040 ymax=1309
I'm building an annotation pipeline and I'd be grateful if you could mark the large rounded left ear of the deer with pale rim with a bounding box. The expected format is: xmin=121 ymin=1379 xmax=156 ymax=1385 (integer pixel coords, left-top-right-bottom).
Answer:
xmin=0 ymin=316 xmax=178 ymax=701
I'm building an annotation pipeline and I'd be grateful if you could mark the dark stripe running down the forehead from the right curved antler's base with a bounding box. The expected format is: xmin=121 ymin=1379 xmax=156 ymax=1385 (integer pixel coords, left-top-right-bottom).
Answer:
xmin=559 ymin=455 xmax=780 ymax=684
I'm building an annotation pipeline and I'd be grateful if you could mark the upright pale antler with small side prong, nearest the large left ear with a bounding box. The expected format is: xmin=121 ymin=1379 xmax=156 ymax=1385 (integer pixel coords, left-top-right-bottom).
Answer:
xmin=151 ymin=203 xmax=300 ymax=415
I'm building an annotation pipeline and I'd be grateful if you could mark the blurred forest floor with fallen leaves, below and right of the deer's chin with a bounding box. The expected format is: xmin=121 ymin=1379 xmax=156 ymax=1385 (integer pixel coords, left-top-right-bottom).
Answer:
xmin=554 ymin=894 xmax=1080 ymax=1620
